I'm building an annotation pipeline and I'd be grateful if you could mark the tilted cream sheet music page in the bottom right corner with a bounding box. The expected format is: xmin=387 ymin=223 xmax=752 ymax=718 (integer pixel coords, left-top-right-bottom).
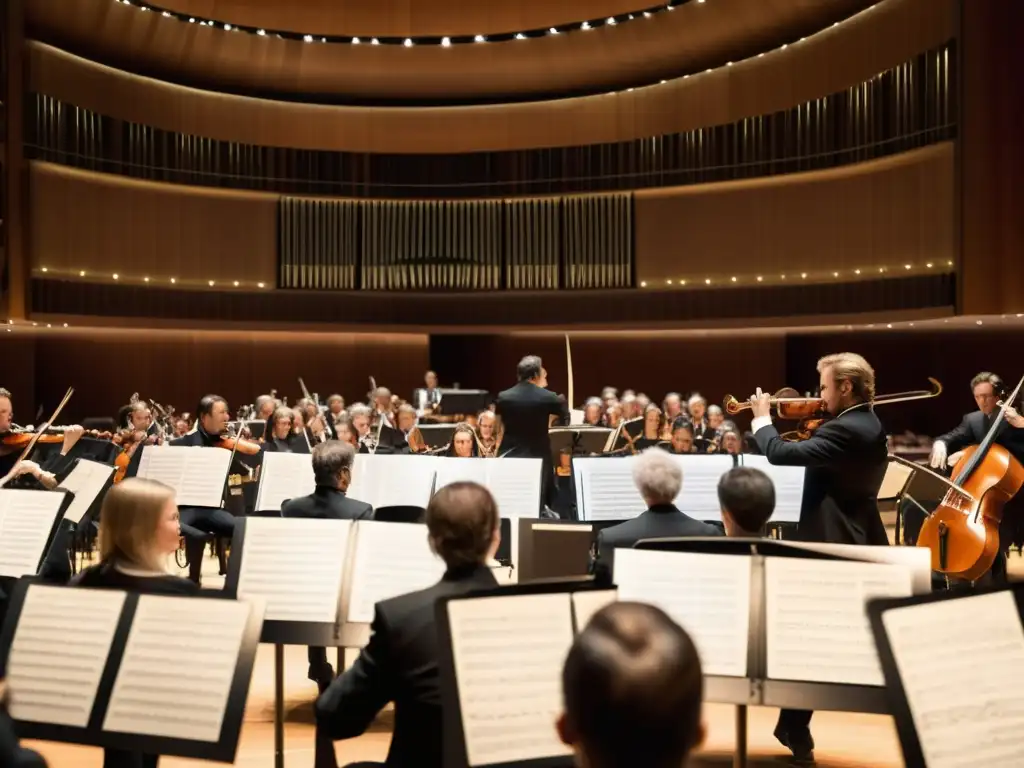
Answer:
xmin=882 ymin=590 xmax=1024 ymax=768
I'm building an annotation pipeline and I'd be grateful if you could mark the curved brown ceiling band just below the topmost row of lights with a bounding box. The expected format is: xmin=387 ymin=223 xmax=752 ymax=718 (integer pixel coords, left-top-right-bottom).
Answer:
xmin=26 ymin=0 xmax=872 ymax=104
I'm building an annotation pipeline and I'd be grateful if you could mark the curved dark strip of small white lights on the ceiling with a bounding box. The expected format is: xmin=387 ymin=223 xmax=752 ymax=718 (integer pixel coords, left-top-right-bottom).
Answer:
xmin=114 ymin=0 xmax=706 ymax=48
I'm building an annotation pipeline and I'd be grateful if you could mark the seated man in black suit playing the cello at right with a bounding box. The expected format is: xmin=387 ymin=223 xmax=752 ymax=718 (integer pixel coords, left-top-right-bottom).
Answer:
xmin=930 ymin=371 xmax=1024 ymax=582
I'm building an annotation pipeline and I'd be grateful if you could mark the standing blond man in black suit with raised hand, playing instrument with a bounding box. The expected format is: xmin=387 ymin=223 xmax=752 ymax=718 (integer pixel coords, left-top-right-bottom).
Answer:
xmin=751 ymin=352 xmax=889 ymax=761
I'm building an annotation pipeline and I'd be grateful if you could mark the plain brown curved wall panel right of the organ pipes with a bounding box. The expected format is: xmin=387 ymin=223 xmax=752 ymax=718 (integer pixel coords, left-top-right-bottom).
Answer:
xmin=636 ymin=142 xmax=955 ymax=286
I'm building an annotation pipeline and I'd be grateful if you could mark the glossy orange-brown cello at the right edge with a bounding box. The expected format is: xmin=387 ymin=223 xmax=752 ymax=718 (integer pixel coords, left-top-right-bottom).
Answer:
xmin=918 ymin=378 xmax=1024 ymax=582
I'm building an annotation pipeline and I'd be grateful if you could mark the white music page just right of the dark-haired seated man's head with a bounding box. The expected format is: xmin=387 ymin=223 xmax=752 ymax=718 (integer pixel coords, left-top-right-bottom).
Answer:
xmin=347 ymin=454 xmax=439 ymax=509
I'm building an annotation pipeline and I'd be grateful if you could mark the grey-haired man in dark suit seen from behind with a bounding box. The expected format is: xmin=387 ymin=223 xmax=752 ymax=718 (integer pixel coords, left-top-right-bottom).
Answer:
xmin=593 ymin=447 xmax=722 ymax=581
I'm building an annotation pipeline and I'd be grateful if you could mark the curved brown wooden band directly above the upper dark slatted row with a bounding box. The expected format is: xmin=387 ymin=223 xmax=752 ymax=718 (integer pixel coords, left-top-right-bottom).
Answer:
xmin=28 ymin=0 xmax=955 ymax=154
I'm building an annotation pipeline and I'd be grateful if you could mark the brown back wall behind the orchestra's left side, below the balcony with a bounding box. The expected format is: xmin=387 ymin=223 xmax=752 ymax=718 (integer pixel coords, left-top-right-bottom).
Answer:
xmin=0 ymin=330 xmax=429 ymax=424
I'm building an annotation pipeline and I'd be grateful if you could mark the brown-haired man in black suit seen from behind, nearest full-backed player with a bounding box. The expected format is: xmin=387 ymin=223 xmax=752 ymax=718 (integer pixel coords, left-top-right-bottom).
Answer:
xmin=316 ymin=482 xmax=501 ymax=768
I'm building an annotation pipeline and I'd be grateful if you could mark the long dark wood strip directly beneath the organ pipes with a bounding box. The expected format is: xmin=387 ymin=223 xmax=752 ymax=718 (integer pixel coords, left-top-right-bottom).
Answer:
xmin=32 ymin=274 xmax=955 ymax=333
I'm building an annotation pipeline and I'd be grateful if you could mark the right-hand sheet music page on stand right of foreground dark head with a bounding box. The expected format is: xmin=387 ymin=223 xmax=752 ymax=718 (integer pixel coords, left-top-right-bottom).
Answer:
xmin=765 ymin=557 xmax=913 ymax=686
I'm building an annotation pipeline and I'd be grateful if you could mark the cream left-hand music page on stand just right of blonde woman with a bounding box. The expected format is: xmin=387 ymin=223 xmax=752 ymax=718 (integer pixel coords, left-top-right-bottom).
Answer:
xmin=239 ymin=518 xmax=352 ymax=624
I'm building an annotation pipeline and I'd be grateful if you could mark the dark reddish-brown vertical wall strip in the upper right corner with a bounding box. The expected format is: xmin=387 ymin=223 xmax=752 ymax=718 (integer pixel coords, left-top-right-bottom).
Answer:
xmin=961 ymin=0 xmax=1024 ymax=313
